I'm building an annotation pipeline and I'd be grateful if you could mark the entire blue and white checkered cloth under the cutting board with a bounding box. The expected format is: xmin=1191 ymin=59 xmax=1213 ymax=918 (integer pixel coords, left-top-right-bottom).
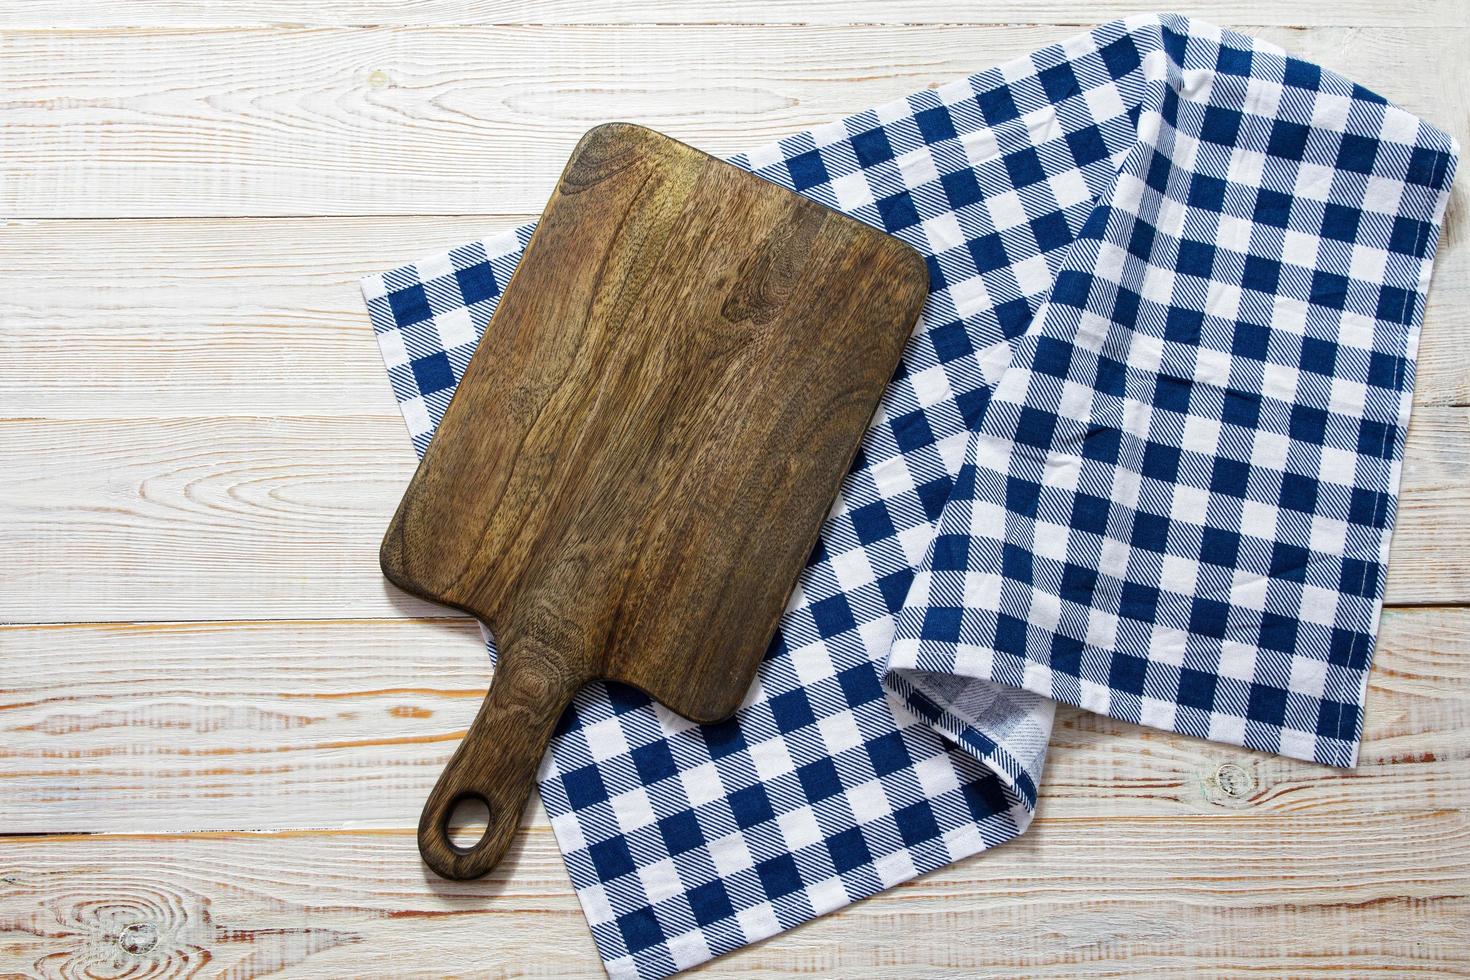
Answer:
xmin=363 ymin=16 xmax=1457 ymax=977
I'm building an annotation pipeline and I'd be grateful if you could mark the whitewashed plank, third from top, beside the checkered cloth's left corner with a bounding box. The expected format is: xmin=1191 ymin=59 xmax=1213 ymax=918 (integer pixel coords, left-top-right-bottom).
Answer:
xmin=0 ymin=213 xmax=1470 ymax=419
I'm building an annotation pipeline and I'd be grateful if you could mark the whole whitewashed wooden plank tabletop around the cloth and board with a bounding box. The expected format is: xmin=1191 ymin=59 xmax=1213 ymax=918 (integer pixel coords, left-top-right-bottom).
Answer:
xmin=0 ymin=0 xmax=1470 ymax=977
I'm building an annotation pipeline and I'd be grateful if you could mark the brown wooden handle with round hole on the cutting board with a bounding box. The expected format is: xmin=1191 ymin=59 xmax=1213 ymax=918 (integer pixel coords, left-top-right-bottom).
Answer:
xmin=419 ymin=641 xmax=588 ymax=882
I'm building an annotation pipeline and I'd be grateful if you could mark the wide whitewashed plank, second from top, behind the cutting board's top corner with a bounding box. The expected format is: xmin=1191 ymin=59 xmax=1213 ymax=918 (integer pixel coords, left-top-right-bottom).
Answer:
xmin=0 ymin=25 xmax=1470 ymax=217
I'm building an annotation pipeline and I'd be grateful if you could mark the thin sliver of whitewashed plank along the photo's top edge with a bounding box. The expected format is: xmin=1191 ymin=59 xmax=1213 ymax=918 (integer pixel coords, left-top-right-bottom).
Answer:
xmin=0 ymin=0 xmax=1470 ymax=28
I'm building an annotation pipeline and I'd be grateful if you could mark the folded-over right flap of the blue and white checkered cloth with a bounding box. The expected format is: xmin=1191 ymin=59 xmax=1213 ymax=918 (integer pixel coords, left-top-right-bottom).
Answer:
xmin=891 ymin=18 xmax=1458 ymax=765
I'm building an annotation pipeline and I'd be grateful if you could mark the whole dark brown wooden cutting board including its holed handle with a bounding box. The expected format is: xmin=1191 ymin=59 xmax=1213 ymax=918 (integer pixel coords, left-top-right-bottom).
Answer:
xmin=382 ymin=123 xmax=928 ymax=879
